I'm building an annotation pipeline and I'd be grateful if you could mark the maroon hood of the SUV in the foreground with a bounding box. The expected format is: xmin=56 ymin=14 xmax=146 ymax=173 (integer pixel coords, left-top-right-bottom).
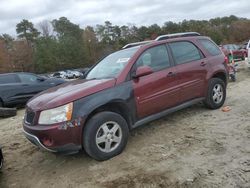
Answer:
xmin=27 ymin=78 xmax=116 ymax=111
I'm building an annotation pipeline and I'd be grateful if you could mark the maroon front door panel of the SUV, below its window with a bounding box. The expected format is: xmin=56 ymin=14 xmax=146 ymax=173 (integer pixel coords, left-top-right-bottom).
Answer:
xmin=133 ymin=67 xmax=180 ymax=118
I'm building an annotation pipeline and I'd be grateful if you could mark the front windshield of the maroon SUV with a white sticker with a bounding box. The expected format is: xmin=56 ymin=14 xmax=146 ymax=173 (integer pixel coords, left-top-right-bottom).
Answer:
xmin=86 ymin=46 xmax=139 ymax=79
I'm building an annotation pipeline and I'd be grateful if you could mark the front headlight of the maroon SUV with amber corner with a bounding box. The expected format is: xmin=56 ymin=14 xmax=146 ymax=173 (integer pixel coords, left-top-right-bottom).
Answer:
xmin=38 ymin=102 xmax=73 ymax=124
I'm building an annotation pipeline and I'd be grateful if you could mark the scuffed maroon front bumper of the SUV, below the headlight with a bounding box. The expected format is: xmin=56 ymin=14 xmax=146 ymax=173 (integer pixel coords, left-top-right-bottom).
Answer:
xmin=23 ymin=119 xmax=82 ymax=153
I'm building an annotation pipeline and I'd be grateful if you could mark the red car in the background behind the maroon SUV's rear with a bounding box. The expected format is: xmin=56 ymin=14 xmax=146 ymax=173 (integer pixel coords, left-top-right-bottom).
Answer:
xmin=220 ymin=44 xmax=247 ymax=60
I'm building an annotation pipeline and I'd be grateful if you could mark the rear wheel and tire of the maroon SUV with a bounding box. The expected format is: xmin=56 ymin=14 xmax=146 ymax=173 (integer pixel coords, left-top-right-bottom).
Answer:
xmin=204 ymin=78 xmax=226 ymax=109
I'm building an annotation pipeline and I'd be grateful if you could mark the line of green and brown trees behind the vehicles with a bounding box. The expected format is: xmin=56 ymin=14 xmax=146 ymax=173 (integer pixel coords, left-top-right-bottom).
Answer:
xmin=0 ymin=15 xmax=250 ymax=73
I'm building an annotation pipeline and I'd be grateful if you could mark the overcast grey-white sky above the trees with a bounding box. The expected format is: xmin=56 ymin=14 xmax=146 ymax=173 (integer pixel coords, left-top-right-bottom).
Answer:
xmin=0 ymin=0 xmax=250 ymax=35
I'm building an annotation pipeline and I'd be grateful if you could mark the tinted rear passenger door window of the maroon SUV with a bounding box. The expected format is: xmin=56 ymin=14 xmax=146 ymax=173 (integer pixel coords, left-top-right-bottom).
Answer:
xmin=169 ymin=41 xmax=203 ymax=65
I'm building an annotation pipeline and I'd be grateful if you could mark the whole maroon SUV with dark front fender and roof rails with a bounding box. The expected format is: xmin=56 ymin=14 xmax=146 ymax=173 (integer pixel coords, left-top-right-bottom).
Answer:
xmin=23 ymin=33 xmax=227 ymax=160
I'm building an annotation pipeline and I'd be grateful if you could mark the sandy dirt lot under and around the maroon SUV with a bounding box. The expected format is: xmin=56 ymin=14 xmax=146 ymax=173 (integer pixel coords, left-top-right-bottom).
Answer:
xmin=0 ymin=71 xmax=250 ymax=188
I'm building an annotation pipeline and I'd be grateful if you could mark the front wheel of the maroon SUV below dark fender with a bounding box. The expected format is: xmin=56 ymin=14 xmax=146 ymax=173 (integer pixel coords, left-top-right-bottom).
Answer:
xmin=83 ymin=112 xmax=129 ymax=161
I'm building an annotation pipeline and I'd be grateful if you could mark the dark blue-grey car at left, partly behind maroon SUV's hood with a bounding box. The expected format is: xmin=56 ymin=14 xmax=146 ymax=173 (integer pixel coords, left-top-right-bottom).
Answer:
xmin=0 ymin=73 xmax=65 ymax=107
